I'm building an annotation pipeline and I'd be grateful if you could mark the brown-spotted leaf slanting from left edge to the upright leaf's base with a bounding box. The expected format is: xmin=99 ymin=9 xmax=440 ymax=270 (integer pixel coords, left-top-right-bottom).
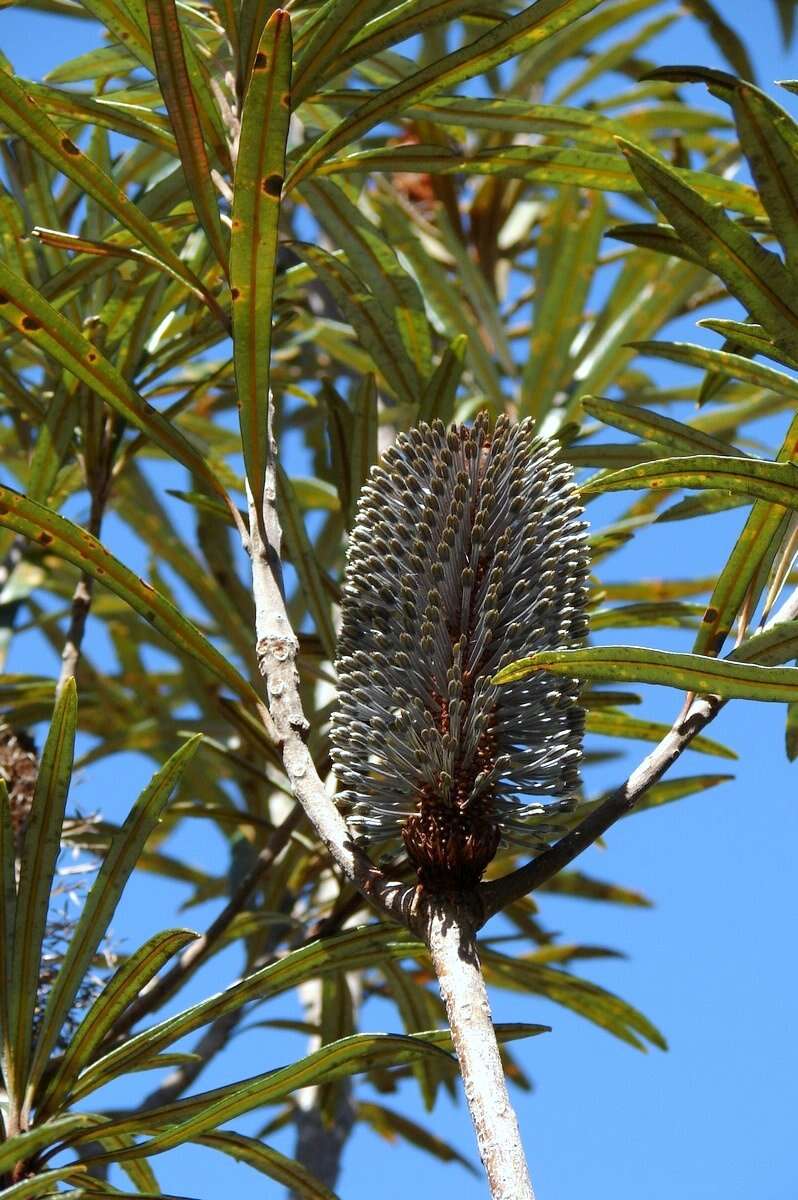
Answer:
xmin=0 ymin=262 xmax=227 ymax=498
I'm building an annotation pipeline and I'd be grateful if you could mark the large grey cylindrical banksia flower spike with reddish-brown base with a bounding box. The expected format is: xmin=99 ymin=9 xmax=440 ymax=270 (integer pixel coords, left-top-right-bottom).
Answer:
xmin=332 ymin=414 xmax=588 ymax=892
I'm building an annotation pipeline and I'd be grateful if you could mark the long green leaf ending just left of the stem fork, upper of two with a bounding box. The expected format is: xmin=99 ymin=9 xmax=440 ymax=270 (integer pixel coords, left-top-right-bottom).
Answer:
xmin=68 ymin=925 xmax=422 ymax=1099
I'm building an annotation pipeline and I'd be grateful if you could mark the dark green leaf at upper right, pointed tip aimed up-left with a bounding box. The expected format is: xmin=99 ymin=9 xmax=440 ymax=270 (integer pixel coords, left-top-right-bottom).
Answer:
xmin=619 ymin=139 xmax=798 ymax=355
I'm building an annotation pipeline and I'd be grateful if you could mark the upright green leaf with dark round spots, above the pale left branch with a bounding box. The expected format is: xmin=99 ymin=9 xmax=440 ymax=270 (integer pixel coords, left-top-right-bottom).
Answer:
xmin=230 ymin=10 xmax=292 ymax=505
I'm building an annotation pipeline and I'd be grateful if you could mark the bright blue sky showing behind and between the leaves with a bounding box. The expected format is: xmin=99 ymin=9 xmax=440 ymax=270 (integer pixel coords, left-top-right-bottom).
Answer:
xmin=0 ymin=7 xmax=798 ymax=1200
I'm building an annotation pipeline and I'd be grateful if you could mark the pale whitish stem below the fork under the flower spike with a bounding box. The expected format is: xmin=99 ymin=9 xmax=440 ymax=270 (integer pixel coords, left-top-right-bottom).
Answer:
xmin=426 ymin=898 xmax=535 ymax=1200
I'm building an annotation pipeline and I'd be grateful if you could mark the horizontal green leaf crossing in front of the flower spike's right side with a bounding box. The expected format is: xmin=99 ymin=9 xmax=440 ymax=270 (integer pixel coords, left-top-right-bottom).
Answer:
xmin=493 ymin=646 xmax=798 ymax=702
